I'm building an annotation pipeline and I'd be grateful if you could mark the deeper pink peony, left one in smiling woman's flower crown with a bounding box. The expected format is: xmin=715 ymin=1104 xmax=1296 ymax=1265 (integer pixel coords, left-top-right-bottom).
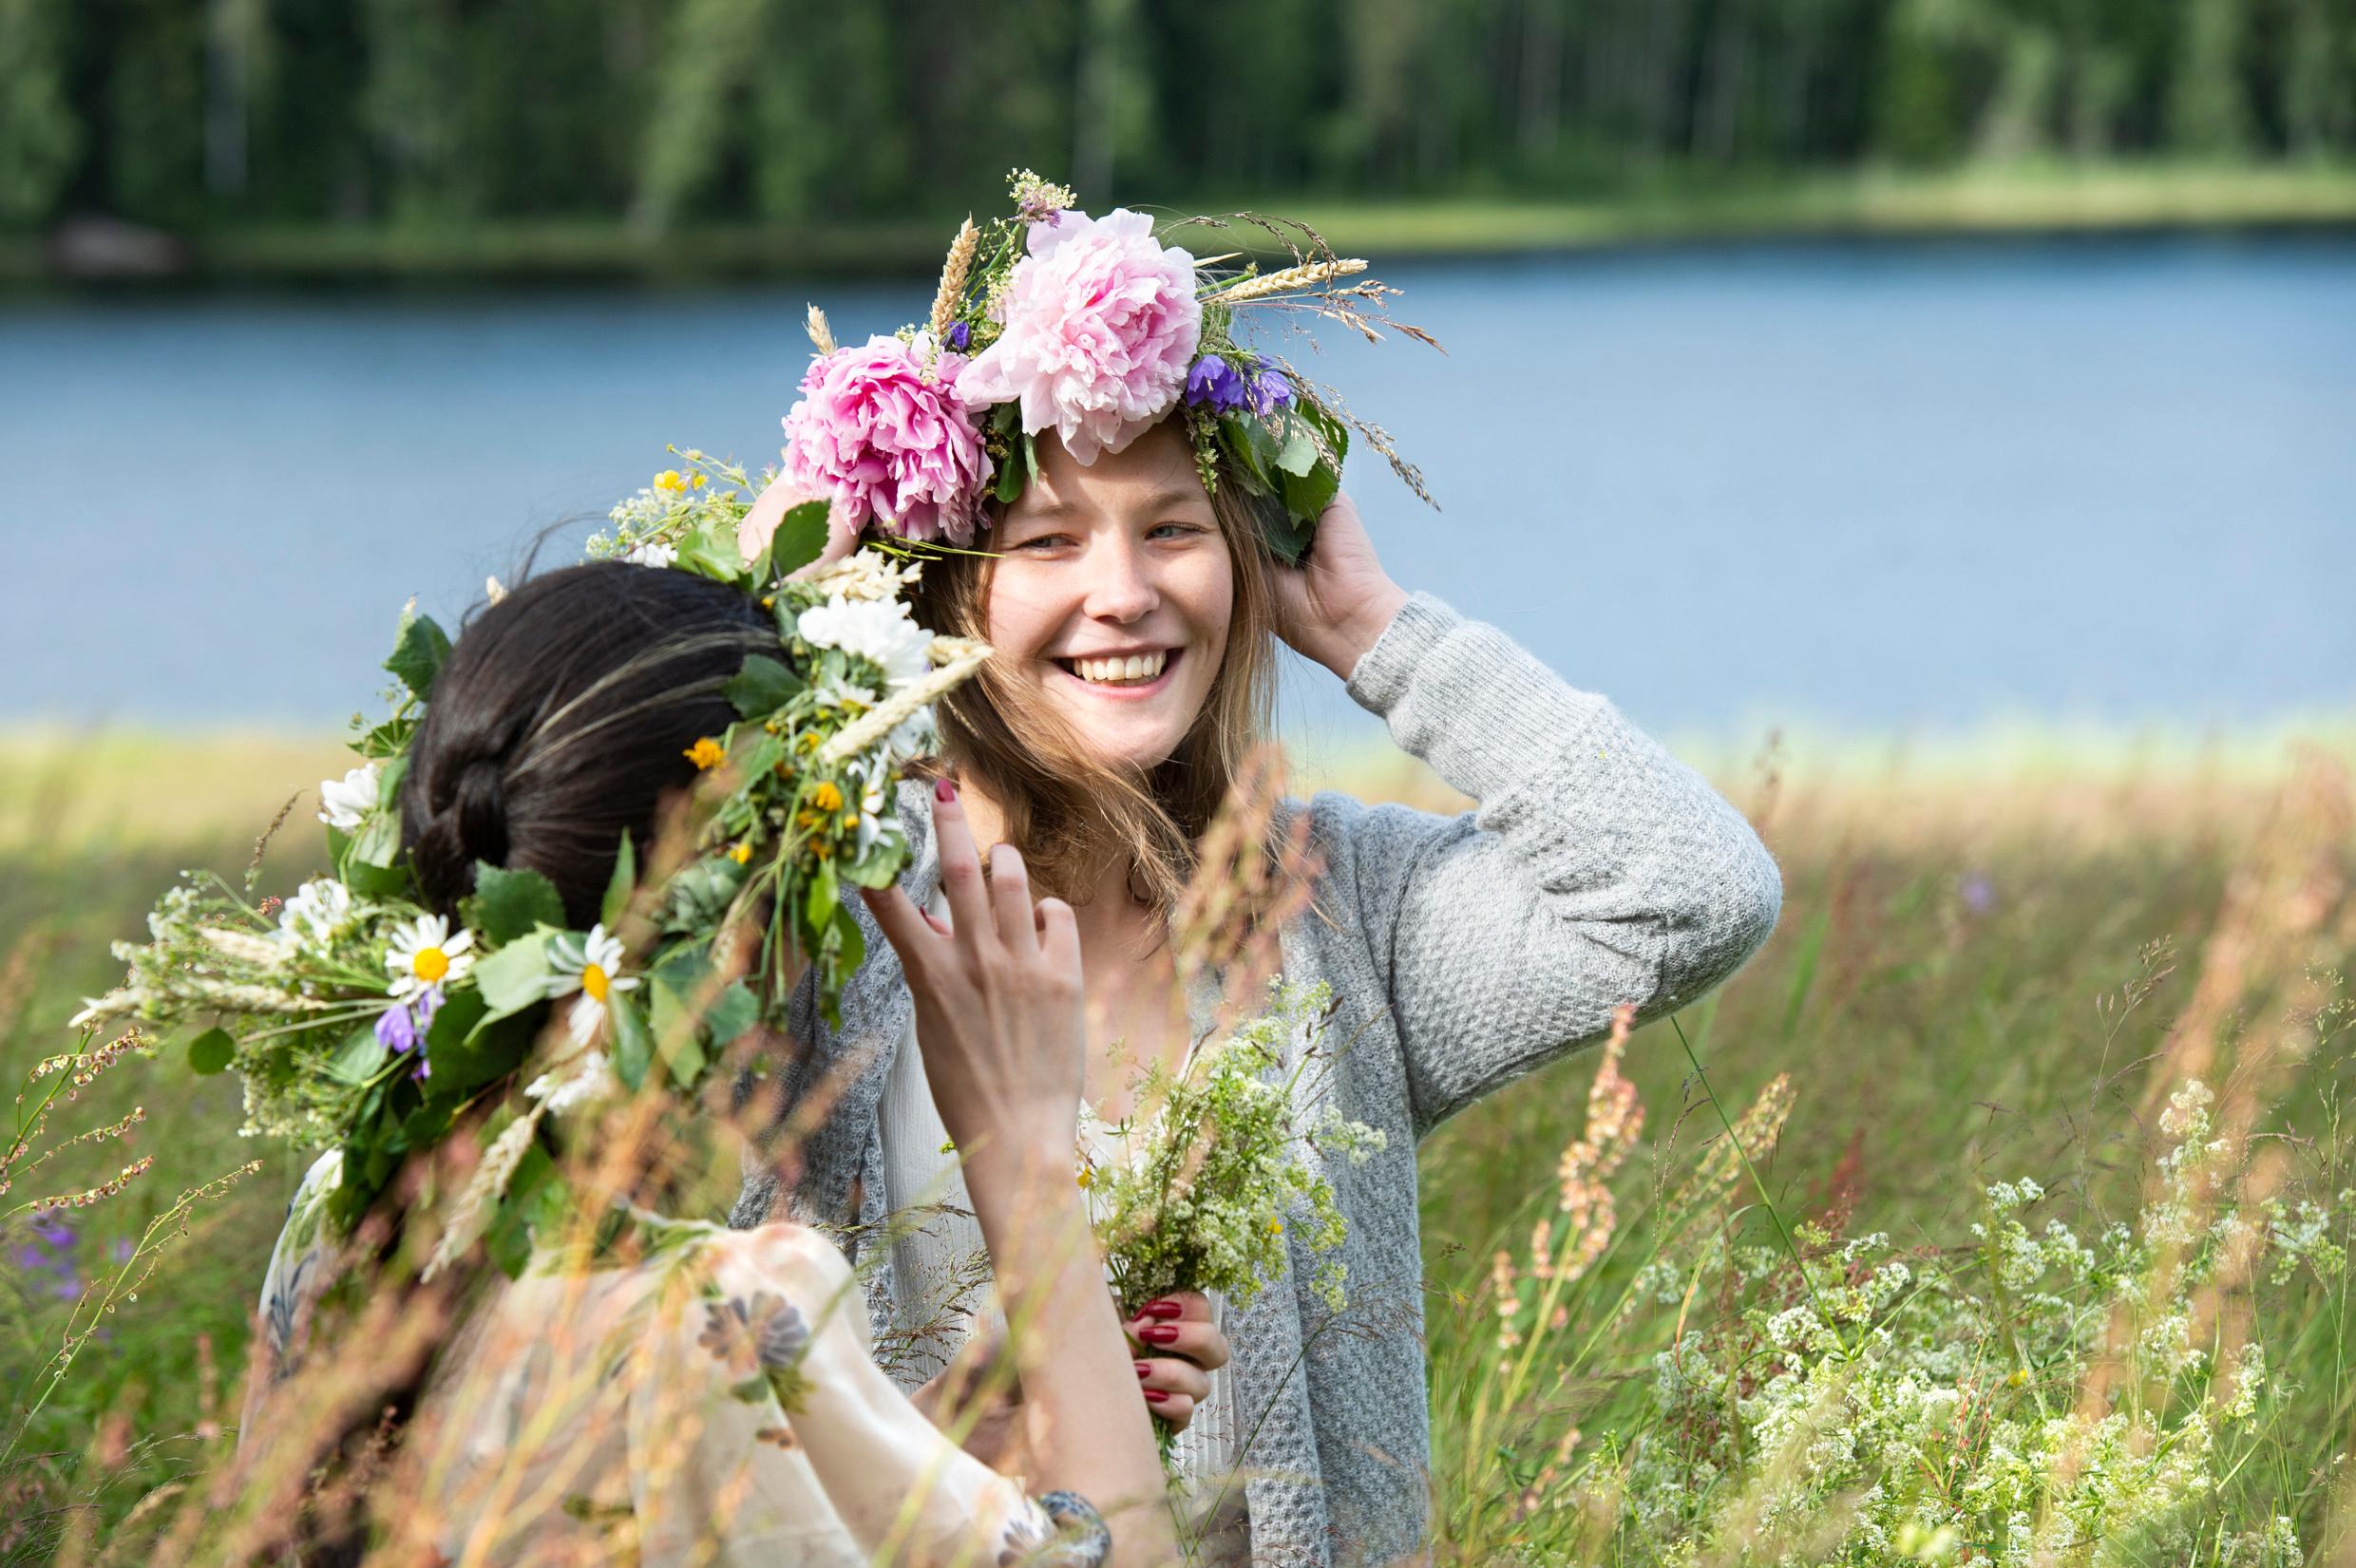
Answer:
xmin=770 ymin=336 xmax=990 ymax=544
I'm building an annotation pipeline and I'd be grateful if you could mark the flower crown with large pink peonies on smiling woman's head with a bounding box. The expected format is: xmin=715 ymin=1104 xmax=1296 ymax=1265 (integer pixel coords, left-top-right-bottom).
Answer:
xmin=742 ymin=169 xmax=1437 ymax=562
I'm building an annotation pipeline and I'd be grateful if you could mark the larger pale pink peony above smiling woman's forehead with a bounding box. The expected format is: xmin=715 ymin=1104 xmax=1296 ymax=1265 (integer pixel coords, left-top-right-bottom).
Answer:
xmin=957 ymin=210 xmax=1202 ymax=463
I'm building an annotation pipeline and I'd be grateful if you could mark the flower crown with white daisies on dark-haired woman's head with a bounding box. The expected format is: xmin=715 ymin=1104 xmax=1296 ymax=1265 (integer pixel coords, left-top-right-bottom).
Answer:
xmin=73 ymin=482 xmax=990 ymax=1274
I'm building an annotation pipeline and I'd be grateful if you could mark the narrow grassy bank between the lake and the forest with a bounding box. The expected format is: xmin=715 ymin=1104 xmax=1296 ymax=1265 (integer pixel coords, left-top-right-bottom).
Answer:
xmin=0 ymin=165 xmax=2356 ymax=287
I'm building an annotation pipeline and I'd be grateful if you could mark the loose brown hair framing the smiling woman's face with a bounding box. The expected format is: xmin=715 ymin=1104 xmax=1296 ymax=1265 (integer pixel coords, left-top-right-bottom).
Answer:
xmin=914 ymin=421 xmax=1280 ymax=911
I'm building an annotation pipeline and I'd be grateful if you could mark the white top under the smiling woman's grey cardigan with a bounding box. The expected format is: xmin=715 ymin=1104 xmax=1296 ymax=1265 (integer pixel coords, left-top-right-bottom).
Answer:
xmin=877 ymin=899 xmax=1239 ymax=1502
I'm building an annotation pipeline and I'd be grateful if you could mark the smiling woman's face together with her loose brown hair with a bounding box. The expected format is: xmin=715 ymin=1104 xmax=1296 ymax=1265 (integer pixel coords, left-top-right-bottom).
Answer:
xmin=917 ymin=419 xmax=1277 ymax=906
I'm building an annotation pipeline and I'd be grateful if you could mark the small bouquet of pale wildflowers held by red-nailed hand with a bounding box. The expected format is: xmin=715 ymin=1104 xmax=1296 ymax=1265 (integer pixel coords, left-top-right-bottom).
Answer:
xmin=1081 ymin=979 xmax=1383 ymax=1312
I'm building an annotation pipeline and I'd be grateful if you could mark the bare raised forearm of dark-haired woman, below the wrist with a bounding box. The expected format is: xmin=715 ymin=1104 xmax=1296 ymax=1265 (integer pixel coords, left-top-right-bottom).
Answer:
xmin=966 ymin=1142 xmax=1176 ymax=1566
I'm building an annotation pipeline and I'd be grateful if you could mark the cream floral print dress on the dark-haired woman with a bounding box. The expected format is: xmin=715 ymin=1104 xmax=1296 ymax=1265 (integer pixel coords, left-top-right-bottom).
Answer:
xmin=242 ymin=1156 xmax=1112 ymax=1568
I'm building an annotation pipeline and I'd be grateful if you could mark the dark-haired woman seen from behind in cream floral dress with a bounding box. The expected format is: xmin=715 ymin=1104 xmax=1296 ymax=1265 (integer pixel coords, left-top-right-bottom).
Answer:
xmin=245 ymin=562 xmax=1173 ymax=1568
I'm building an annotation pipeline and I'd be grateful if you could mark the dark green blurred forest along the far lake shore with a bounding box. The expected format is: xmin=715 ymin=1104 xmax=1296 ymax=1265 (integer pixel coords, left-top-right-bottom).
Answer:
xmin=0 ymin=0 xmax=2356 ymax=231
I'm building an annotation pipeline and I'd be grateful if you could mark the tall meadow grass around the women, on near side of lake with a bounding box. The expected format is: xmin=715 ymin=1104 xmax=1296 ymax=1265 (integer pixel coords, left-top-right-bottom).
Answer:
xmin=0 ymin=726 xmax=2356 ymax=1563
